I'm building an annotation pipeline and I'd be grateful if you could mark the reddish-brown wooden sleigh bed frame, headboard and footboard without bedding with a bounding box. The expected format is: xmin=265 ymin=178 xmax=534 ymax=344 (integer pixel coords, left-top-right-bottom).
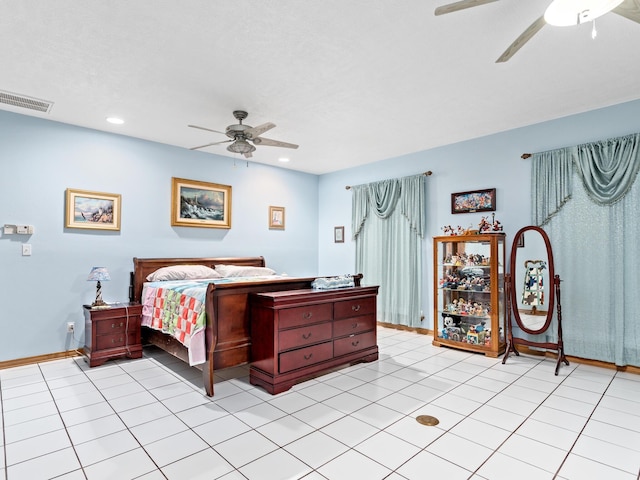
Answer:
xmin=129 ymin=257 xmax=362 ymax=396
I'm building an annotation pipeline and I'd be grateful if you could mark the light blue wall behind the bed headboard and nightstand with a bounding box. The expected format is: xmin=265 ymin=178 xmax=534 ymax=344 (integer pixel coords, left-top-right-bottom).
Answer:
xmin=0 ymin=111 xmax=318 ymax=361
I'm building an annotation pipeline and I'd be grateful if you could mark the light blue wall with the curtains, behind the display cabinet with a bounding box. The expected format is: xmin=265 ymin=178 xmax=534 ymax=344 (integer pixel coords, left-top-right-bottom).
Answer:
xmin=318 ymin=97 xmax=640 ymax=329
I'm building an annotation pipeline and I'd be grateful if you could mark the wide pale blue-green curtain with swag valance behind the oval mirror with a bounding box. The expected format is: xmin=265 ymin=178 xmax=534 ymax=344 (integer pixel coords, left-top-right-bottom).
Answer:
xmin=532 ymin=134 xmax=640 ymax=366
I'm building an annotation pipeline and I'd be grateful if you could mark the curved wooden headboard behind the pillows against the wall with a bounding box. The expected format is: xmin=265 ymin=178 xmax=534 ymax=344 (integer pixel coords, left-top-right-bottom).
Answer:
xmin=129 ymin=257 xmax=266 ymax=303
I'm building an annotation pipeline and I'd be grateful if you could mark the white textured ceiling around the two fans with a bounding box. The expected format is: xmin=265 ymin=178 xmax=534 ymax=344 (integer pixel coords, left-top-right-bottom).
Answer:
xmin=0 ymin=0 xmax=640 ymax=174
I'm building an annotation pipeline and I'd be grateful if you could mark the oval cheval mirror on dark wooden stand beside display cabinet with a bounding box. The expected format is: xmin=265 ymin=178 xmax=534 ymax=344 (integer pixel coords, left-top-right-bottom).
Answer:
xmin=502 ymin=226 xmax=569 ymax=375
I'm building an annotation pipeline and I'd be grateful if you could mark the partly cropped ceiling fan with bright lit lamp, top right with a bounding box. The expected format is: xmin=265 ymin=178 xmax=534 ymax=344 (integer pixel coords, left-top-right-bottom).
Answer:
xmin=435 ymin=0 xmax=640 ymax=63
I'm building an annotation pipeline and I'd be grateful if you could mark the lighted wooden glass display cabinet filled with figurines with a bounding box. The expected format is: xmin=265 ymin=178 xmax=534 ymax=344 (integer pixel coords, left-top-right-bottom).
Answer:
xmin=433 ymin=233 xmax=506 ymax=357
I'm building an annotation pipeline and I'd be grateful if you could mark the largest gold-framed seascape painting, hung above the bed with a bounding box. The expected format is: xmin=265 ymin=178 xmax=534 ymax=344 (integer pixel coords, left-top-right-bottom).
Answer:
xmin=171 ymin=177 xmax=231 ymax=228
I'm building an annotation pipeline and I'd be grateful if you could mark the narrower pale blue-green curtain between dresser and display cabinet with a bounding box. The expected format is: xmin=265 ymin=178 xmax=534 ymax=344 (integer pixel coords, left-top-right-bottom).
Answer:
xmin=352 ymin=175 xmax=426 ymax=327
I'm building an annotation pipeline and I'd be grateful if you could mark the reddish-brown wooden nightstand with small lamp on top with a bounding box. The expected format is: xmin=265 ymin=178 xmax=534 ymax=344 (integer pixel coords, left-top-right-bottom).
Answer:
xmin=83 ymin=303 xmax=142 ymax=367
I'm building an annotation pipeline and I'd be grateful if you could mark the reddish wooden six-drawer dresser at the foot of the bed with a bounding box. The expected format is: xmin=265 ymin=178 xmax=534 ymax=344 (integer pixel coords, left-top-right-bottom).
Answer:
xmin=250 ymin=286 xmax=378 ymax=394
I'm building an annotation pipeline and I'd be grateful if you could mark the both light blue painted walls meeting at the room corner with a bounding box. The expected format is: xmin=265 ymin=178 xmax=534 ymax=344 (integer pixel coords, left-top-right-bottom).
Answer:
xmin=5 ymin=101 xmax=640 ymax=361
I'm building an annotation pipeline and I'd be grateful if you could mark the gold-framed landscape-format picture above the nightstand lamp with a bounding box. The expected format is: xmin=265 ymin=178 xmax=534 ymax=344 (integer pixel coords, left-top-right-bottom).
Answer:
xmin=64 ymin=188 xmax=122 ymax=230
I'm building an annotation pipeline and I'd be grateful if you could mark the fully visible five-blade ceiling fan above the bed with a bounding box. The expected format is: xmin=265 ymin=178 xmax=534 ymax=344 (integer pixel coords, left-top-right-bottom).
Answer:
xmin=188 ymin=110 xmax=298 ymax=158
